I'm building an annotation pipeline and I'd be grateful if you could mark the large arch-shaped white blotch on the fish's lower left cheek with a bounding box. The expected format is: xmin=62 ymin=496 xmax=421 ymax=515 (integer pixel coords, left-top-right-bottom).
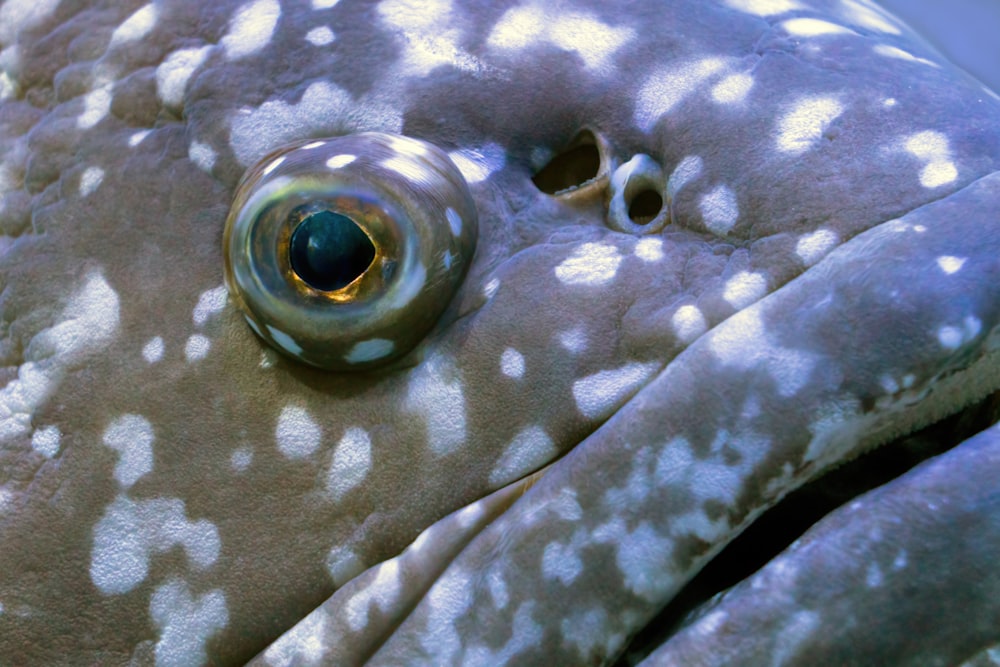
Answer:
xmin=90 ymin=496 xmax=221 ymax=595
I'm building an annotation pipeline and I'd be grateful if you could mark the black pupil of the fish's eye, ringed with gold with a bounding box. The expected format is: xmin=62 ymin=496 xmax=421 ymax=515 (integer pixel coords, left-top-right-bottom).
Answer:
xmin=288 ymin=211 xmax=375 ymax=292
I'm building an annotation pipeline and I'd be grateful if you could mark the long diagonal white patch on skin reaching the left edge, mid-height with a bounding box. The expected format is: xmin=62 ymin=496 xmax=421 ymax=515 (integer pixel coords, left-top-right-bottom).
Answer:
xmin=0 ymin=272 xmax=119 ymax=442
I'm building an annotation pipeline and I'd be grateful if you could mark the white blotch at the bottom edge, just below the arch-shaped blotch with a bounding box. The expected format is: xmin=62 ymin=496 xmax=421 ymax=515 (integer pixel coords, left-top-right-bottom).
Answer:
xmin=149 ymin=579 xmax=229 ymax=667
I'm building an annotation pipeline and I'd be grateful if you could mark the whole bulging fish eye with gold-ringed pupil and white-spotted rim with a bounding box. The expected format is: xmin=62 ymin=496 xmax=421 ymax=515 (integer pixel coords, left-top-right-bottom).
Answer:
xmin=223 ymin=133 xmax=477 ymax=370
